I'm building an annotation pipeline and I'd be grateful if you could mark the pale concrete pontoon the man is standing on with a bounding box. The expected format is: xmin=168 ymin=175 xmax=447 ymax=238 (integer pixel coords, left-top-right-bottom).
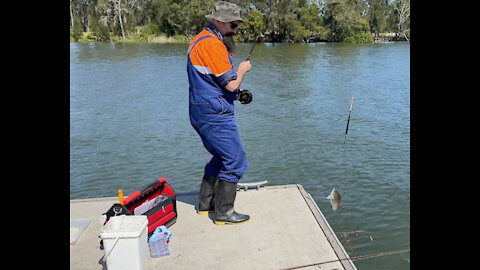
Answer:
xmin=70 ymin=185 xmax=356 ymax=270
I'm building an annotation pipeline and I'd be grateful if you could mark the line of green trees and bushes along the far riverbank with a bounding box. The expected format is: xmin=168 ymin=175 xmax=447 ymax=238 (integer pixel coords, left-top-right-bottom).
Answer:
xmin=70 ymin=0 xmax=410 ymax=43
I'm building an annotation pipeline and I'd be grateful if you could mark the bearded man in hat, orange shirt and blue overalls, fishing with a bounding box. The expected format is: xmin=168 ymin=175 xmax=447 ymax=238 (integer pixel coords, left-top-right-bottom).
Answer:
xmin=187 ymin=1 xmax=251 ymax=225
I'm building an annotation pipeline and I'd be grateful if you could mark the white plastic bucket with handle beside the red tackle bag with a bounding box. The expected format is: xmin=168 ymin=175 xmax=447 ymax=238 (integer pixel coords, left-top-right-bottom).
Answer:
xmin=100 ymin=215 xmax=148 ymax=270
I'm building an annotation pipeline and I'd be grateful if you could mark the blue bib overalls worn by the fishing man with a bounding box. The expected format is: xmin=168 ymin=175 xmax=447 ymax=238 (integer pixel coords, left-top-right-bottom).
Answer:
xmin=187 ymin=28 xmax=248 ymax=182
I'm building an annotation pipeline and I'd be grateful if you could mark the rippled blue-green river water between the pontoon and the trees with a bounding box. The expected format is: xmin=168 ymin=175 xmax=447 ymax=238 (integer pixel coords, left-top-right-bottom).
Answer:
xmin=70 ymin=43 xmax=410 ymax=270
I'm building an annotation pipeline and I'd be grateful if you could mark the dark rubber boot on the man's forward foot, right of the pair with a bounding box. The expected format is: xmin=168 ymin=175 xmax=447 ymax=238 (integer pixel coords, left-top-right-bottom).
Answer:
xmin=215 ymin=180 xmax=250 ymax=225
